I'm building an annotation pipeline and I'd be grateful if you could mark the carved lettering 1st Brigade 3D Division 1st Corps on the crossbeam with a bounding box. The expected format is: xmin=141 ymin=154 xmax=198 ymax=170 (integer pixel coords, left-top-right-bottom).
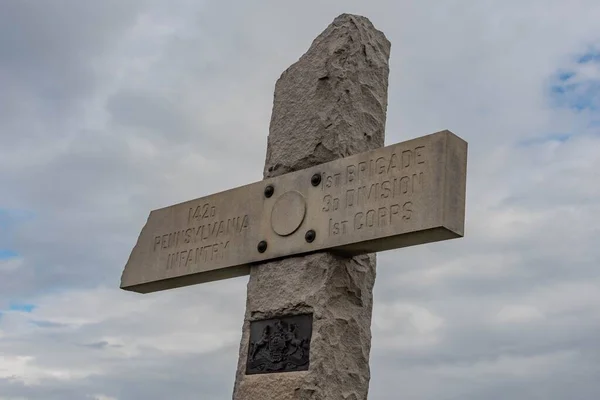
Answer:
xmin=321 ymin=146 xmax=428 ymax=236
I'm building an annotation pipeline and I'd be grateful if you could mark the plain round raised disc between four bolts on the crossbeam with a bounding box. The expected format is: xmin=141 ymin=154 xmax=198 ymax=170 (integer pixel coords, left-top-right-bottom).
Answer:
xmin=271 ymin=191 xmax=306 ymax=236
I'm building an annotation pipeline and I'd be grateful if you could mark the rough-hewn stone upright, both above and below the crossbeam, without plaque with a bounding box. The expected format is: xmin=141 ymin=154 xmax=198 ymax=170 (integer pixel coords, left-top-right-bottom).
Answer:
xmin=233 ymin=14 xmax=390 ymax=400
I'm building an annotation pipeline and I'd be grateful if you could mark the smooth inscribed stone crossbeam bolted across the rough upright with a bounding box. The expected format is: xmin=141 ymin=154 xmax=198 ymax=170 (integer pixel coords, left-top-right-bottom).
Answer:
xmin=121 ymin=131 xmax=467 ymax=293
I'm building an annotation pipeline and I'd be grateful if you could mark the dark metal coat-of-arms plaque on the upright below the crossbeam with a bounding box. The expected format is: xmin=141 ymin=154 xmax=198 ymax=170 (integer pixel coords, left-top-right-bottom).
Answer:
xmin=246 ymin=314 xmax=312 ymax=375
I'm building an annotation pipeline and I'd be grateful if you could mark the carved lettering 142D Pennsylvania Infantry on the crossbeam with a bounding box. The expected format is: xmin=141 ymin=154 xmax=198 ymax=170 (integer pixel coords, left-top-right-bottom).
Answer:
xmin=152 ymin=203 xmax=249 ymax=270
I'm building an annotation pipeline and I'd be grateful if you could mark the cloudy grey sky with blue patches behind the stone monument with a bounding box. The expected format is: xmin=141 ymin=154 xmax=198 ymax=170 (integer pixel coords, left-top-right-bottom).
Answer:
xmin=0 ymin=0 xmax=600 ymax=400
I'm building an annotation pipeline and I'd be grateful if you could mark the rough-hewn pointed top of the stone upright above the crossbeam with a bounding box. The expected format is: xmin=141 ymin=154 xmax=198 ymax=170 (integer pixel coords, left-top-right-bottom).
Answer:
xmin=264 ymin=14 xmax=390 ymax=178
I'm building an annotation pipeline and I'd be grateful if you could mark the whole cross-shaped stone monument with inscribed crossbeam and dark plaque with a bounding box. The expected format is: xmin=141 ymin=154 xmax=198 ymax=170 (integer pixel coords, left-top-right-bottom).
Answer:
xmin=121 ymin=14 xmax=467 ymax=400
